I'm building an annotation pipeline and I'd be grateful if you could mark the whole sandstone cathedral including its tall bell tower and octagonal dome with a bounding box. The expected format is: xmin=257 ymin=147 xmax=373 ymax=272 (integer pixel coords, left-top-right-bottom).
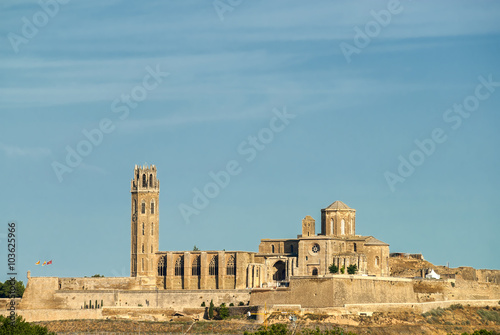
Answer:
xmin=130 ymin=165 xmax=389 ymax=290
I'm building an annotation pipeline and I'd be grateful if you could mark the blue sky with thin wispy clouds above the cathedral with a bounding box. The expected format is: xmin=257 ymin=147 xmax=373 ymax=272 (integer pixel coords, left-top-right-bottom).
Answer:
xmin=0 ymin=0 xmax=500 ymax=281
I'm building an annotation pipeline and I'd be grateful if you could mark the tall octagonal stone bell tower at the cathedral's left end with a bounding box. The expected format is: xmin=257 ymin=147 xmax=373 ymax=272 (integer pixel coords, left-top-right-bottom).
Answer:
xmin=130 ymin=165 xmax=160 ymax=277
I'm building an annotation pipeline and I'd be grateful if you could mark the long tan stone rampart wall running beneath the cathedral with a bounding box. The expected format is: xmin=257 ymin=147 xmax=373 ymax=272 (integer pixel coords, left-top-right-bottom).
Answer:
xmin=10 ymin=275 xmax=500 ymax=321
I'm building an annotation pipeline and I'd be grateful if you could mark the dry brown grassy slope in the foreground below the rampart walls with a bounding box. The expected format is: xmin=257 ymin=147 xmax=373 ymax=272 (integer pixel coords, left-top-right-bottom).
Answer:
xmin=36 ymin=305 xmax=500 ymax=335
